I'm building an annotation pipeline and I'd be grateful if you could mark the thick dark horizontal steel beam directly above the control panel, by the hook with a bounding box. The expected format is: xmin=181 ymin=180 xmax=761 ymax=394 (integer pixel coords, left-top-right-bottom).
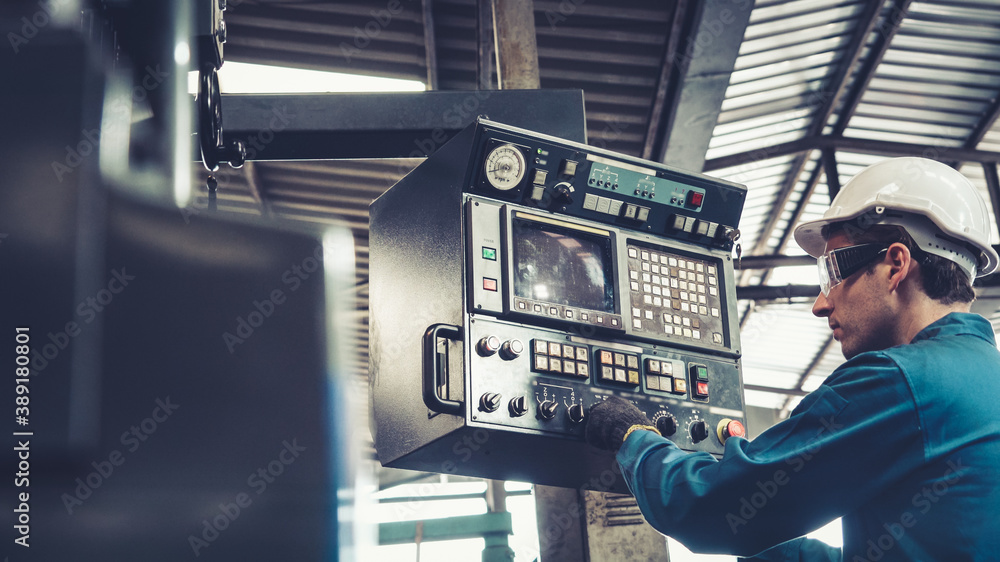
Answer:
xmin=211 ymin=90 xmax=587 ymax=160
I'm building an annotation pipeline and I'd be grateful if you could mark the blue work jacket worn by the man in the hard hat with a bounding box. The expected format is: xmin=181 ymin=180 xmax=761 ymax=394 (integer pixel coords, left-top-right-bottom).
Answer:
xmin=617 ymin=313 xmax=1000 ymax=562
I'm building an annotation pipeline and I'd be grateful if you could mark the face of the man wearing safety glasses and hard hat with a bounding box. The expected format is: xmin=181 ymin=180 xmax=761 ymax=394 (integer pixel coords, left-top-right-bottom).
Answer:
xmin=813 ymin=232 xmax=897 ymax=359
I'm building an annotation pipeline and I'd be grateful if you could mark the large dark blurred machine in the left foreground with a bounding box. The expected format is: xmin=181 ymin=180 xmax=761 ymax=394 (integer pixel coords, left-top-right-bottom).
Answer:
xmin=0 ymin=0 xmax=362 ymax=562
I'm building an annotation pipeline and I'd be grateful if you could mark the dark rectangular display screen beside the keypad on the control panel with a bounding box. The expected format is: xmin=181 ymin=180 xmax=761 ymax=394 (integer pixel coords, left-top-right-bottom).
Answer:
xmin=511 ymin=217 xmax=615 ymax=313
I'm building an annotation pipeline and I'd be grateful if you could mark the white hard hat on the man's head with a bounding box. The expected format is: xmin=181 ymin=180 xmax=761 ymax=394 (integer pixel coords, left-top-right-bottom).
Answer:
xmin=795 ymin=157 xmax=998 ymax=279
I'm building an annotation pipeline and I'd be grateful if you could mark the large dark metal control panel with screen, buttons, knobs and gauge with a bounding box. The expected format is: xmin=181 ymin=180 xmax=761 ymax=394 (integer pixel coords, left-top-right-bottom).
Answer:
xmin=370 ymin=120 xmax=746 ymax=492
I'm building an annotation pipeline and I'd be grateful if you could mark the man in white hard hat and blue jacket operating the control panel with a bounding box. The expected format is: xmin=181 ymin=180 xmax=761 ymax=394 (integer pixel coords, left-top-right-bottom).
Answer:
xmin=587 ymin=158 xmax=1000 ymax=562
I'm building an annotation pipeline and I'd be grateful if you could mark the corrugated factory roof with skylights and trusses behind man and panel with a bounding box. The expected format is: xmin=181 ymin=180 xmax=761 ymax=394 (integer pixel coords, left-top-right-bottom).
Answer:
xmin=196 ymin=0 xmax=1000 ymax=414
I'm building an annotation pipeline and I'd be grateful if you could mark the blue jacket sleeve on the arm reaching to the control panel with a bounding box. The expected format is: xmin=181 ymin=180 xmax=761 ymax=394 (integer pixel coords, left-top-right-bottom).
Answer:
xmin=617 ymin=352 xmax=923 ymax=556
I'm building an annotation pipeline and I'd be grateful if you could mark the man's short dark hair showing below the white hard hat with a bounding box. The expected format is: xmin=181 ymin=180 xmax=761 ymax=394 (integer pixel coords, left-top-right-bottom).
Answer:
xmin=826 ymin=223 xmax=976 ymax=304
